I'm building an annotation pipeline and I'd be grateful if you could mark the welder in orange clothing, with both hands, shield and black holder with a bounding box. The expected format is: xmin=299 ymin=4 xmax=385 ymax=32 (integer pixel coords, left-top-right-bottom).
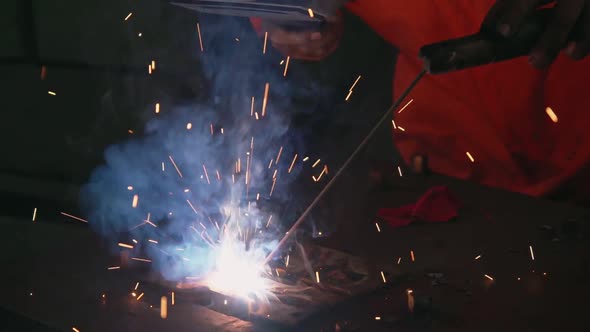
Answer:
xmin=179 ymin=0 xmax=590 ymax=204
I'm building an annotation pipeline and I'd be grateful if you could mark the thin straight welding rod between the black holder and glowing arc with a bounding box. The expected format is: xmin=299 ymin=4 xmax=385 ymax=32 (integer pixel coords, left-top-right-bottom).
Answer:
xmin=263 ymin=69 xmax=426 ymax=265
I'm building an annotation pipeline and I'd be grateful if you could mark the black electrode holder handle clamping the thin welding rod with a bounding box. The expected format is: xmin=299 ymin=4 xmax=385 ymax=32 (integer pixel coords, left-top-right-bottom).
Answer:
xmin=419 ymin=9 xmax=553 ymax=74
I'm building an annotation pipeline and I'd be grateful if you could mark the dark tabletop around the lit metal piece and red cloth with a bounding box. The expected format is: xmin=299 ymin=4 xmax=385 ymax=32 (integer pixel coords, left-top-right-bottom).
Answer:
xmin=0 ymin=172 xmax=590 ymax=332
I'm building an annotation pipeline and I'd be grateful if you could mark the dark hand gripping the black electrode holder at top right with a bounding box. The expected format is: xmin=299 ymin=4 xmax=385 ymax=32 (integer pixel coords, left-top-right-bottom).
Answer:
xmin=482 ymin=0 xmax=590 ymax=68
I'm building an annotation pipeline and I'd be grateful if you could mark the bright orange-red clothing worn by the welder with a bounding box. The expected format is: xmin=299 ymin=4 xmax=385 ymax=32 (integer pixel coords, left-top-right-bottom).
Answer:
xmin=266 ymin=0 xmax=590 ymax=202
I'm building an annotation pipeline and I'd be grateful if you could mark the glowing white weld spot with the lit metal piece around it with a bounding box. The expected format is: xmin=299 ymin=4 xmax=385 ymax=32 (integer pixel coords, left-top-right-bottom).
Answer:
xmin=171 ymin=244 xmax=392 ymax=326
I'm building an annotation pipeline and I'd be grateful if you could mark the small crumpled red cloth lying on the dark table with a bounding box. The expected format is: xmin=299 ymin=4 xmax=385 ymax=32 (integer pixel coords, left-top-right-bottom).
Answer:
xmin=377 ymin=186 xmax=460 ymax=227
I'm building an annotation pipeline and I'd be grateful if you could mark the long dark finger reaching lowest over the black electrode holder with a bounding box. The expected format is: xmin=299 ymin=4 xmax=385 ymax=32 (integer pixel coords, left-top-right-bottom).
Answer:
xmin=529 ymin=0 xmax=585 ymax=68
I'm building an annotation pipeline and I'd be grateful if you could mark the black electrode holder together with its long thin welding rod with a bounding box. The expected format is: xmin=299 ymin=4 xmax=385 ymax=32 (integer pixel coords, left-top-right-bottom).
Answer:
xmin=264 ymin=9 xmax=564 ymax=264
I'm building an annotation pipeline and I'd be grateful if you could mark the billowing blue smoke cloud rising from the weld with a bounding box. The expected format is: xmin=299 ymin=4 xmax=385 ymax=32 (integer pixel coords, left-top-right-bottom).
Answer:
xmin=81 ymin=14 xmax=328 ymax=280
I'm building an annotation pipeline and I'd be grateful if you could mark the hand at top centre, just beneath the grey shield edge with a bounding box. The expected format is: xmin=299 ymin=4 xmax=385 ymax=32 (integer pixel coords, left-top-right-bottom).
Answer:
xmin=268 ymin=13 xmax=344 ymax=61
